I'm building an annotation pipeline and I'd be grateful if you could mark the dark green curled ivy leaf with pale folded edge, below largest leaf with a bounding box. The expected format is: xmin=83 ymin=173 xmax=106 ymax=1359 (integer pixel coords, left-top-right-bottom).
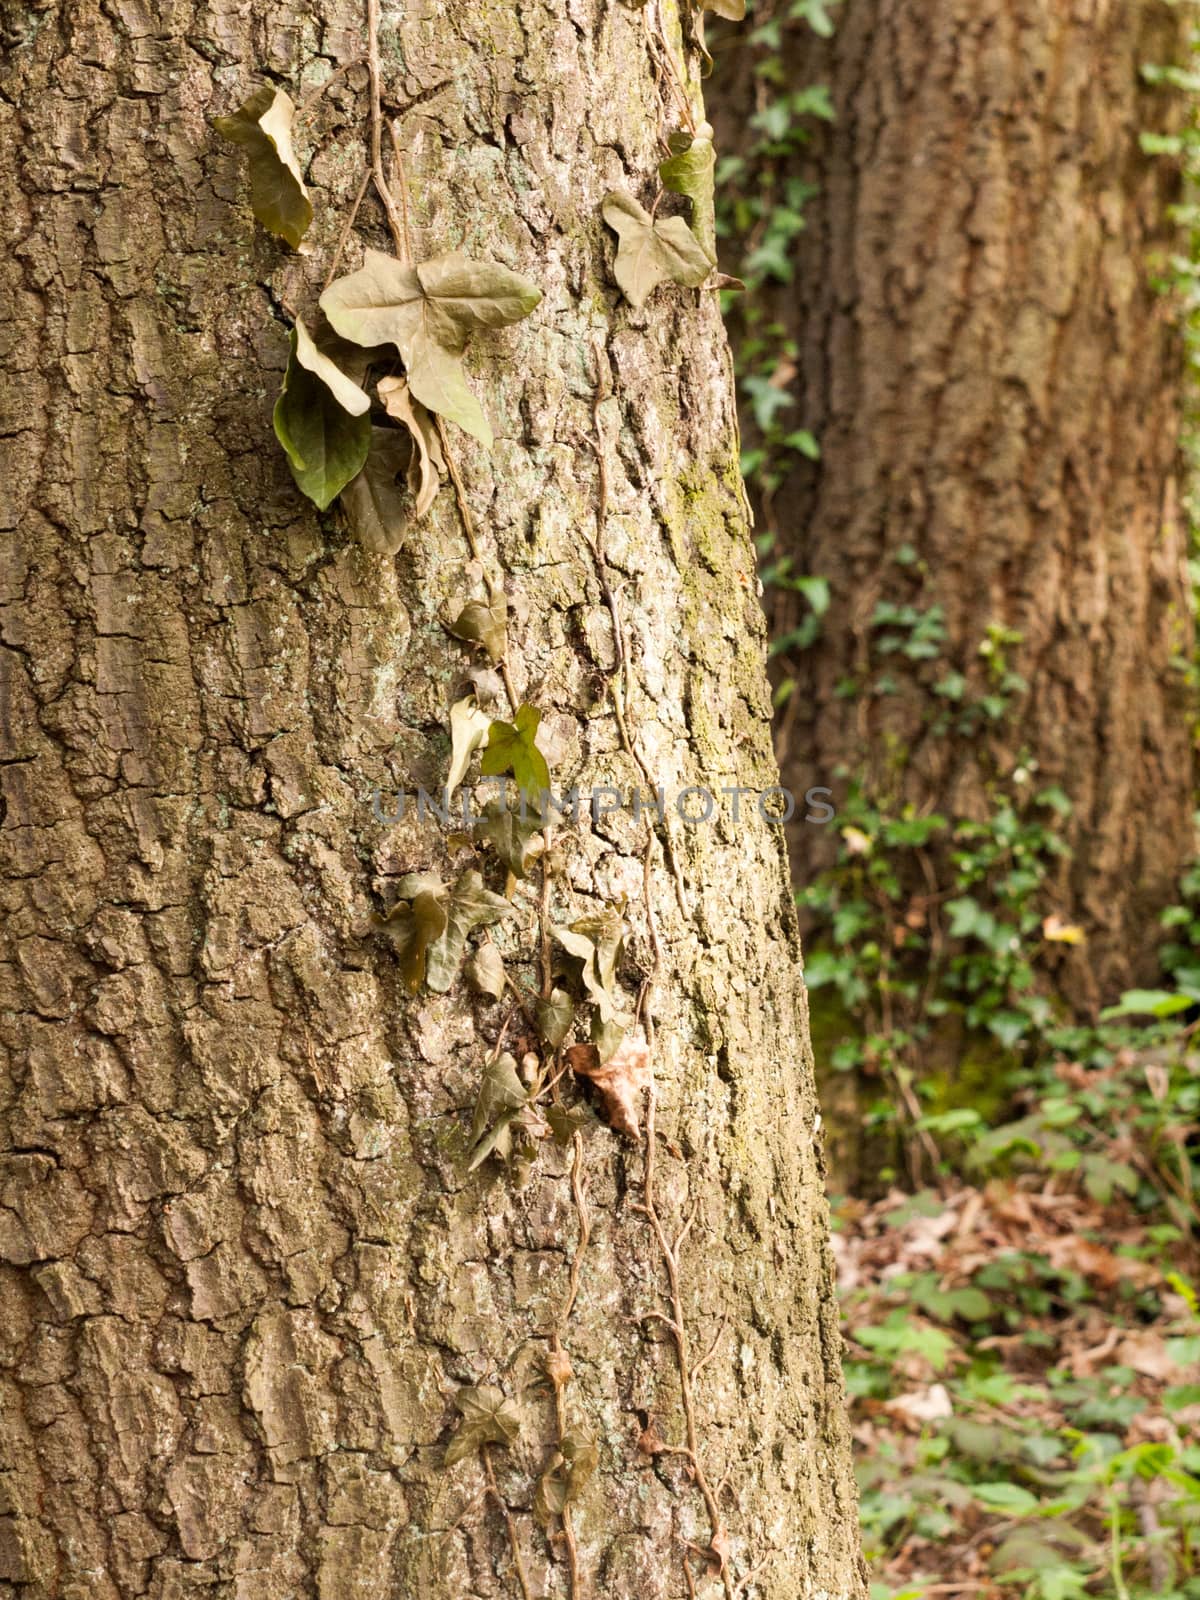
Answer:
xmin=274 ymin=322 xmax=371 ymax=510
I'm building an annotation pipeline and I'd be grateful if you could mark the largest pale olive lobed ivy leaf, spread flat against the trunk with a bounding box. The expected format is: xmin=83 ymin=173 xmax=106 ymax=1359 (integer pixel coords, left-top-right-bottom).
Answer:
xmin=320 ymin=250 xmax=542 ymax=448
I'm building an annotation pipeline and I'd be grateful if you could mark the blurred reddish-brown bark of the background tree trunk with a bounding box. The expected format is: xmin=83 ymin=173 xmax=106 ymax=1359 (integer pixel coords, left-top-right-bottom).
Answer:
xmin=717 ymin=0 xmax=1194 ymax=1008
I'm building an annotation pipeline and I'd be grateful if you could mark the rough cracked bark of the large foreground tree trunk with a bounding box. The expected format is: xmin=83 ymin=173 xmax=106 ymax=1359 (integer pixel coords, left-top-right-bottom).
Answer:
xmin=0 ymin=0 xmax=861 ymax=1600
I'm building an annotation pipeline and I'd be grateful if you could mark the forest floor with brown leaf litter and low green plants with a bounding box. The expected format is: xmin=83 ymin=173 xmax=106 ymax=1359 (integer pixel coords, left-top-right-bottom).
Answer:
xmin=834 ymin=1029 xmax=1200 ymax=1600
